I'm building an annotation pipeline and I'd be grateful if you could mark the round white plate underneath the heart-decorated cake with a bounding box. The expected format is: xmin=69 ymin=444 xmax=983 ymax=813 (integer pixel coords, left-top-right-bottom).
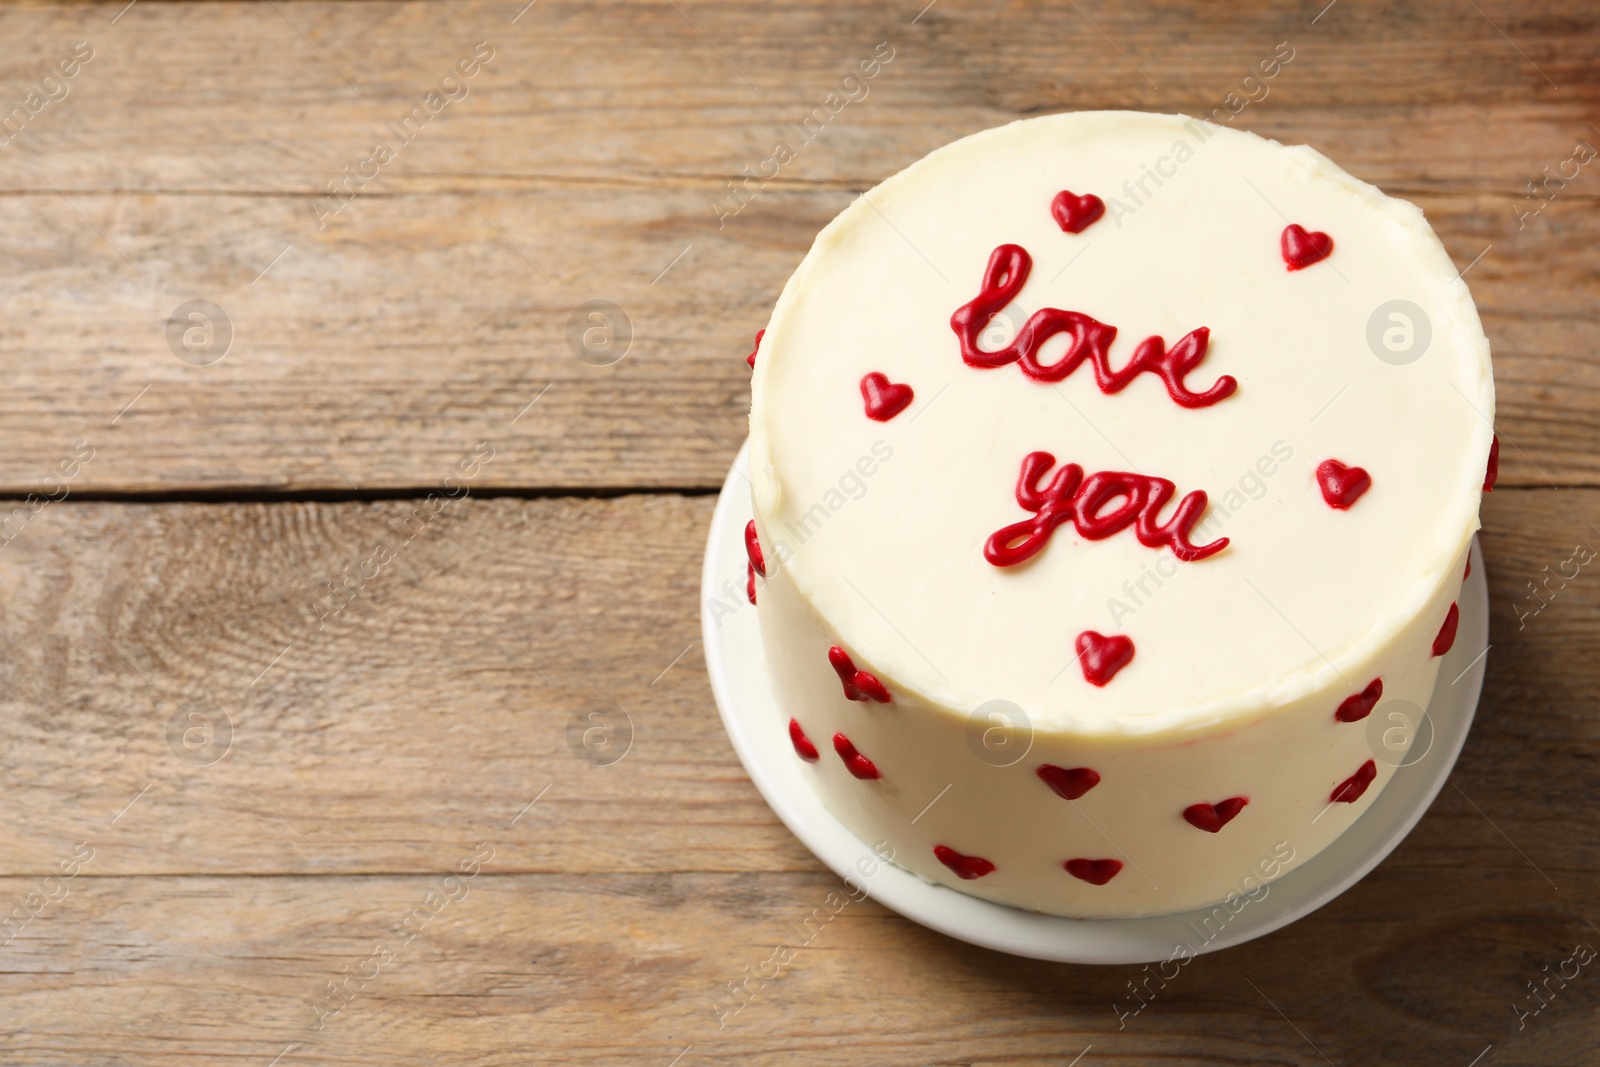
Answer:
xmin=701 ymin=448 xmax=1490 ymax=963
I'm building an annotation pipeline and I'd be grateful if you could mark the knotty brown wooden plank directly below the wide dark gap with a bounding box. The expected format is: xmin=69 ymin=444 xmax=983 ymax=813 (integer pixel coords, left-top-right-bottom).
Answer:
xmin=0 ymin=490 xmax=1600 ymax=886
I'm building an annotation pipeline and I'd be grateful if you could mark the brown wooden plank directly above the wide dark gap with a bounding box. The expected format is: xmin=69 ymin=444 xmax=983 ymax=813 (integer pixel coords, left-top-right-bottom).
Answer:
xmin=0 ymin=187 xmax=1600 ymax=494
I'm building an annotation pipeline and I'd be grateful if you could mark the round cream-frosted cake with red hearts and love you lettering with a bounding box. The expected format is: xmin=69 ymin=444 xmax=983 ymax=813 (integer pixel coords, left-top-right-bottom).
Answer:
xmin=746 ymin=112 xmax=1494 ymax=917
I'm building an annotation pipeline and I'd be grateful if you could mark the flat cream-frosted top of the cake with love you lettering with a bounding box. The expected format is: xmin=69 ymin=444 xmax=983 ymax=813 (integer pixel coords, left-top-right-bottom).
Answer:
xmin=750 ymin=112 xmax=1494 ymax=733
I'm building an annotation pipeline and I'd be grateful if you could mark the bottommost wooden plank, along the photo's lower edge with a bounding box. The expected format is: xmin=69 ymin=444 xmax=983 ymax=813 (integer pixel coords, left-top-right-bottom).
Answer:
xmin=0 ymin=863 xmax=1600 ymax=1067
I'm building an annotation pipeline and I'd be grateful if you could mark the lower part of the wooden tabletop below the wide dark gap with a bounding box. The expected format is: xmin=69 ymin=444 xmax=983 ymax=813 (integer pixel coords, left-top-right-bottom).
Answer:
xmin=0 ymin=490 xmax=1600 ymax=1065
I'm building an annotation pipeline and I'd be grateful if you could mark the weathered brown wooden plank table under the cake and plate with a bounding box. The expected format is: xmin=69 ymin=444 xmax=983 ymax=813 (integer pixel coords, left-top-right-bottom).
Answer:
xmin=0 ymin=0 xmax=1600 ymax=1067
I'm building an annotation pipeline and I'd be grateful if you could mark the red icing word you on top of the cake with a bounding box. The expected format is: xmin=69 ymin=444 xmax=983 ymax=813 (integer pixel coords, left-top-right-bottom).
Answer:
xmin=984 ymin=453 xmax=1227 ymax=566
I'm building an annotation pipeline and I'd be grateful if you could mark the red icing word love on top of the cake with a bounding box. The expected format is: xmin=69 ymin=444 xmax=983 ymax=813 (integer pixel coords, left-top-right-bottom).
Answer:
xmin=950 ymin=245 xmax=1238 ymax=408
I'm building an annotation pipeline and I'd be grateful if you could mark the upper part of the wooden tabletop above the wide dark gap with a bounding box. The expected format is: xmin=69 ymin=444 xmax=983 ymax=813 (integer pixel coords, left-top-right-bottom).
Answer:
xmin=0 ymin=0 xmax=1600 ymax=494
